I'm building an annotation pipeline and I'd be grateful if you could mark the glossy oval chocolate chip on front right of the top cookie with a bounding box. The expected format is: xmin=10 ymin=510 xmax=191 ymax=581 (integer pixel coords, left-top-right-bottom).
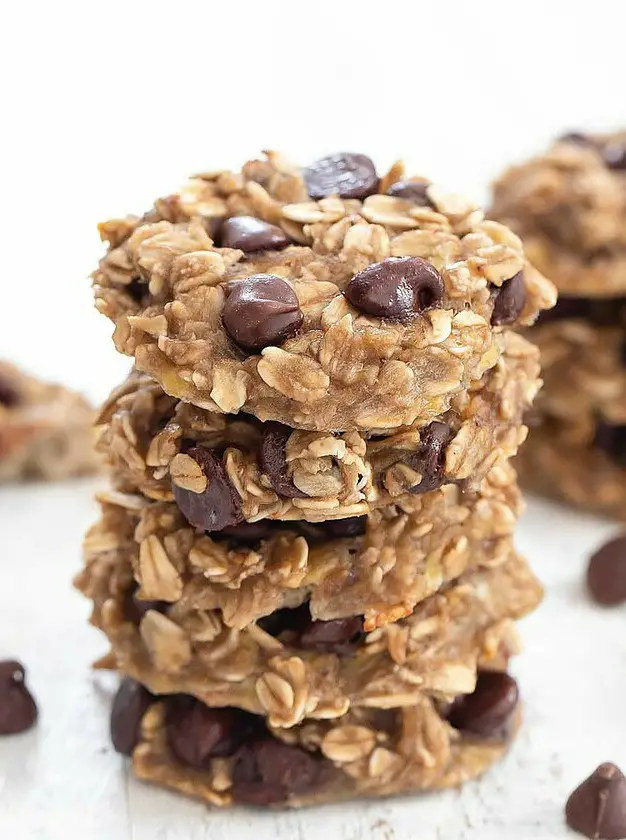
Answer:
xmin=344 ymin=257 xmax=444 ymax=320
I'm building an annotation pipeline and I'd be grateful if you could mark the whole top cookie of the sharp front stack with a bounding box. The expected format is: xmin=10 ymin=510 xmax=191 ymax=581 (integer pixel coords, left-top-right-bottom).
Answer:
xmin=94 ymin=152 xmax=555 ymax=431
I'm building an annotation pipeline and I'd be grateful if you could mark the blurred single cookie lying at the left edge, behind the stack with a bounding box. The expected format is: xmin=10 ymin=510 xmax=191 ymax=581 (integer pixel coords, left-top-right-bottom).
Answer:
xmin=0 ymin=362 xmax=97 ymax=482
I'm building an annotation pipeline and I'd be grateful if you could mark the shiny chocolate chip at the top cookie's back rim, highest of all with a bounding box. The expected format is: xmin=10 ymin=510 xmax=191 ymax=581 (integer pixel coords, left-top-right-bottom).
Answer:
xmin=303 ymin=152 xmax=378 ymax=200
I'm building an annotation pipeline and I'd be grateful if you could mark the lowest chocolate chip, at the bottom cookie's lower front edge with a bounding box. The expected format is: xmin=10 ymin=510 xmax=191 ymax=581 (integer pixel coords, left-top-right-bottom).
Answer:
xmin=232 ymin=737 xmax=324 ymax=805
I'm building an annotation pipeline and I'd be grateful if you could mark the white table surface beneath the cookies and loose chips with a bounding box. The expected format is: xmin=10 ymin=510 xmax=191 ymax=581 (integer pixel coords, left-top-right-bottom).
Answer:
xmin=0 ymin=481 xmax=626 ymax=840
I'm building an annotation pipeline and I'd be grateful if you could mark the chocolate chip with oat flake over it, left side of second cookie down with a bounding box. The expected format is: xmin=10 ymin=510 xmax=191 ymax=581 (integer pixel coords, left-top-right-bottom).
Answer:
xmin=172 ymin=446 xmax=243 ymax=531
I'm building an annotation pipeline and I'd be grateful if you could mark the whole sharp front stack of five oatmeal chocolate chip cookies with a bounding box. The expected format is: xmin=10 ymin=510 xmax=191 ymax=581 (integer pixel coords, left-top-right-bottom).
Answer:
xmin=77 ymin=153 xmax=555 ymax=806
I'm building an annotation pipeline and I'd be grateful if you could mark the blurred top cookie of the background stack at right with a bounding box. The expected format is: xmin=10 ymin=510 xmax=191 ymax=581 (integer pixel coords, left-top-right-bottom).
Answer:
xmin=493 ymin=132 xmax=626 ymax=297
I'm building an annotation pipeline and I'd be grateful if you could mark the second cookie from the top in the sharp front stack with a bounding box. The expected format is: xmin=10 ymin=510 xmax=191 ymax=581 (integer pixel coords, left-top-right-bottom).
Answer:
xmin=98 ymin=332 xmax=541 ymax=531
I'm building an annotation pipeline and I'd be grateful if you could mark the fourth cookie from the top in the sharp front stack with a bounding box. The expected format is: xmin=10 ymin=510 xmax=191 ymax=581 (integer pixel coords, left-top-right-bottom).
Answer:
xmin=77 ymin=516 xmax=541 ymax=727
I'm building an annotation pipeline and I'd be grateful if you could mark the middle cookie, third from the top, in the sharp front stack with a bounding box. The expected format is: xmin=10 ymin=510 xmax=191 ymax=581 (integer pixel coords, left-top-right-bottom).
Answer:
xmin=80 ymin=464 xmax=521 ymax=629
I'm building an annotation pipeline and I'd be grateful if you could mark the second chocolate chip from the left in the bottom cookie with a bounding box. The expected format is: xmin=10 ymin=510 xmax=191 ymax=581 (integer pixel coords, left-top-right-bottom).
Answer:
xmin=165 ymin=694 xmax=254 ymax=770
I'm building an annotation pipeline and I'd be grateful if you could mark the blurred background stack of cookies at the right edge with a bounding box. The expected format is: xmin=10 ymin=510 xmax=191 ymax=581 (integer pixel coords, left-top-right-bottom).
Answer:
xmin=493 ymin=133 xmax=626 ymax=519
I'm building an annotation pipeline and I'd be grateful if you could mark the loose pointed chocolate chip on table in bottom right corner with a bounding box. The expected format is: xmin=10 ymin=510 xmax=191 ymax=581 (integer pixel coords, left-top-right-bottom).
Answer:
xmin=565 ymin=762 xmax=626 ymax=840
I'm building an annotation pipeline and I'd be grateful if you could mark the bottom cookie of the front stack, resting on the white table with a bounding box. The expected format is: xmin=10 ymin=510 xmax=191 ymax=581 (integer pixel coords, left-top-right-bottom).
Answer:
xmin=112 ymin=672 xmax=521 ymax=807
